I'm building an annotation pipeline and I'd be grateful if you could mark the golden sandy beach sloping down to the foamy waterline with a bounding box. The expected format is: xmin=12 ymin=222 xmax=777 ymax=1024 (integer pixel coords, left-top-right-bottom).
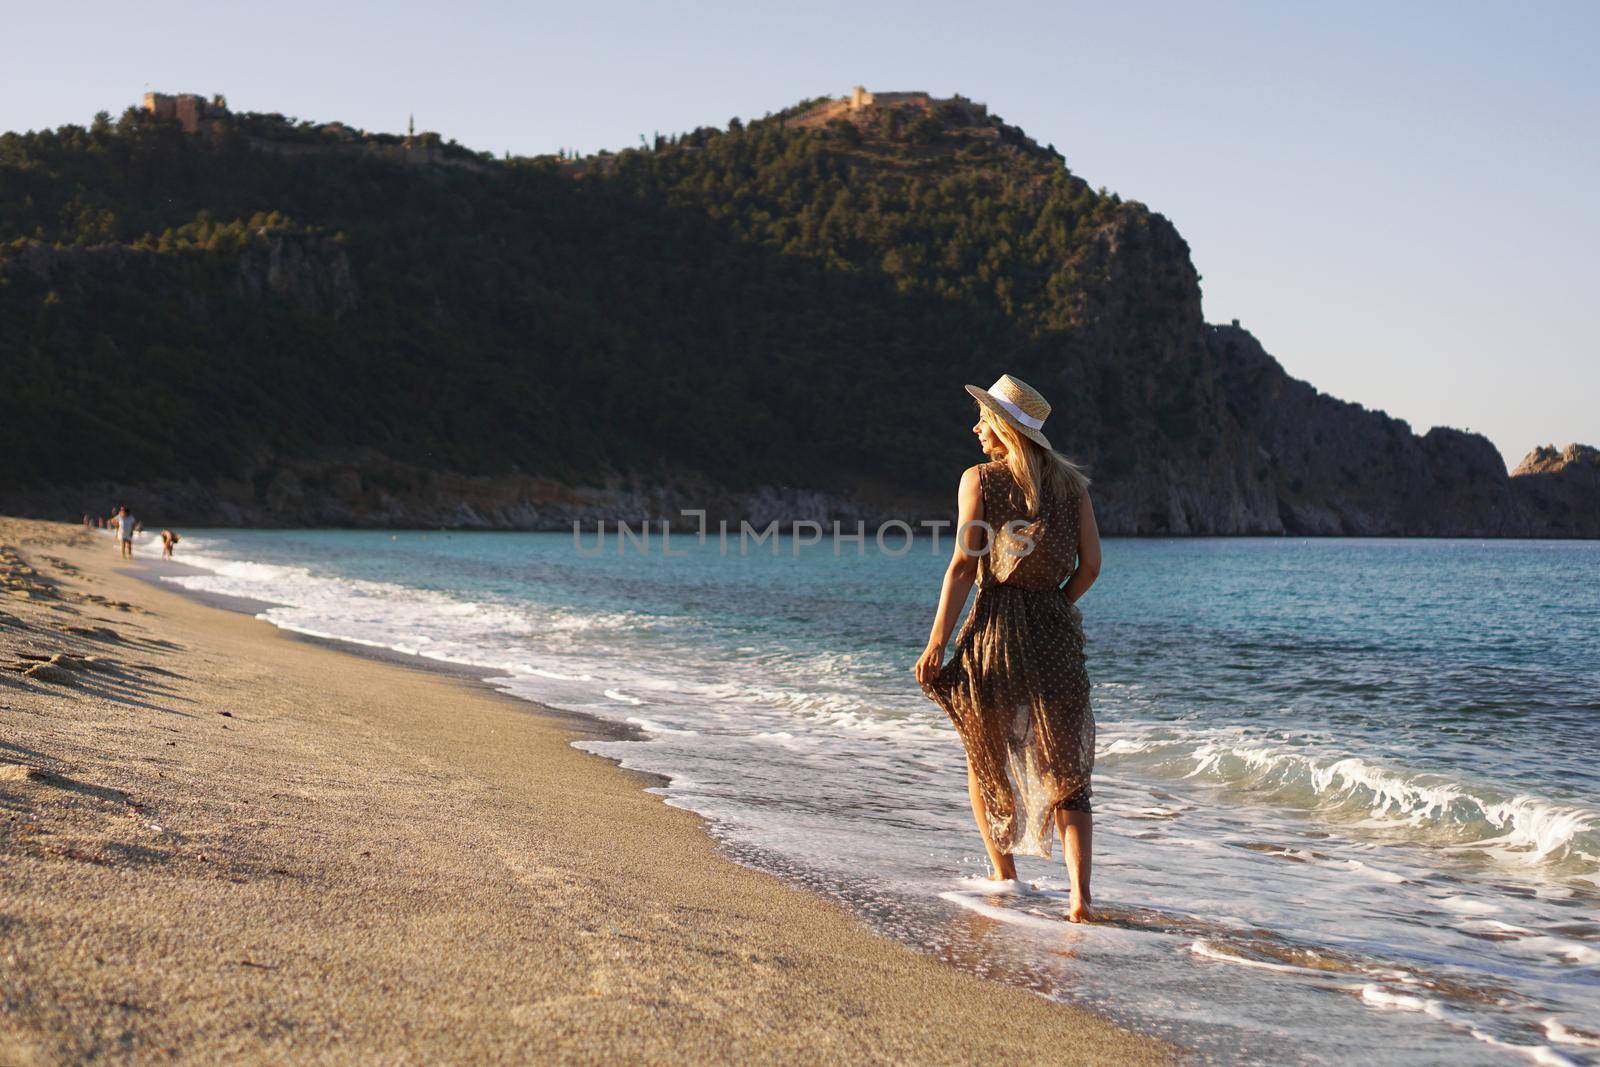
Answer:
xmin=0 ymin=520 xmax=1176 ymax=1064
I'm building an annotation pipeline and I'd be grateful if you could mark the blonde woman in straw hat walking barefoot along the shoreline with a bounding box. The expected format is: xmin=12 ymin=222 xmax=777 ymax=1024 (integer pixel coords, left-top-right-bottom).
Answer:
xmin=915 ymin=374 xmax=1101 ymax=923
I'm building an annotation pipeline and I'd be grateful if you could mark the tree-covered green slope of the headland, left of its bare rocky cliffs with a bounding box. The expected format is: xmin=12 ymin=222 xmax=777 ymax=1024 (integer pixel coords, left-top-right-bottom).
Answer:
xmin=0 ymin=97 xmax=1118 ymax=488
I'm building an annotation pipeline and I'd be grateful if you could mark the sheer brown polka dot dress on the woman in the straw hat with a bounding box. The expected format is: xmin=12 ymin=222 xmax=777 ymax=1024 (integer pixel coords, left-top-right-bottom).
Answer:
xmin=922 ymin=461 xmax=1094 ymax=856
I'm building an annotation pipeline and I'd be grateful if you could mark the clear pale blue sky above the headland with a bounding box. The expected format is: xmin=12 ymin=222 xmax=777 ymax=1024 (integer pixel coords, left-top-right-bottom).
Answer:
xmin=0 ymin=0 xmax=1600 ymax=464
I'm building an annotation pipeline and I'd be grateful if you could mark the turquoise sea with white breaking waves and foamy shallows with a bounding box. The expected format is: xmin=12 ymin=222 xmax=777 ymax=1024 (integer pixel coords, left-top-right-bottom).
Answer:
xmin=144 ymin=528 xmax=1600 ymax=1064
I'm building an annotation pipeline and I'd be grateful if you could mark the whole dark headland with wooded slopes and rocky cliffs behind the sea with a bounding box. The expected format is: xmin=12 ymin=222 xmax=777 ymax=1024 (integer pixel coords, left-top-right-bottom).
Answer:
xmin=0 ymin=86 xmax=1600 ymax=537
